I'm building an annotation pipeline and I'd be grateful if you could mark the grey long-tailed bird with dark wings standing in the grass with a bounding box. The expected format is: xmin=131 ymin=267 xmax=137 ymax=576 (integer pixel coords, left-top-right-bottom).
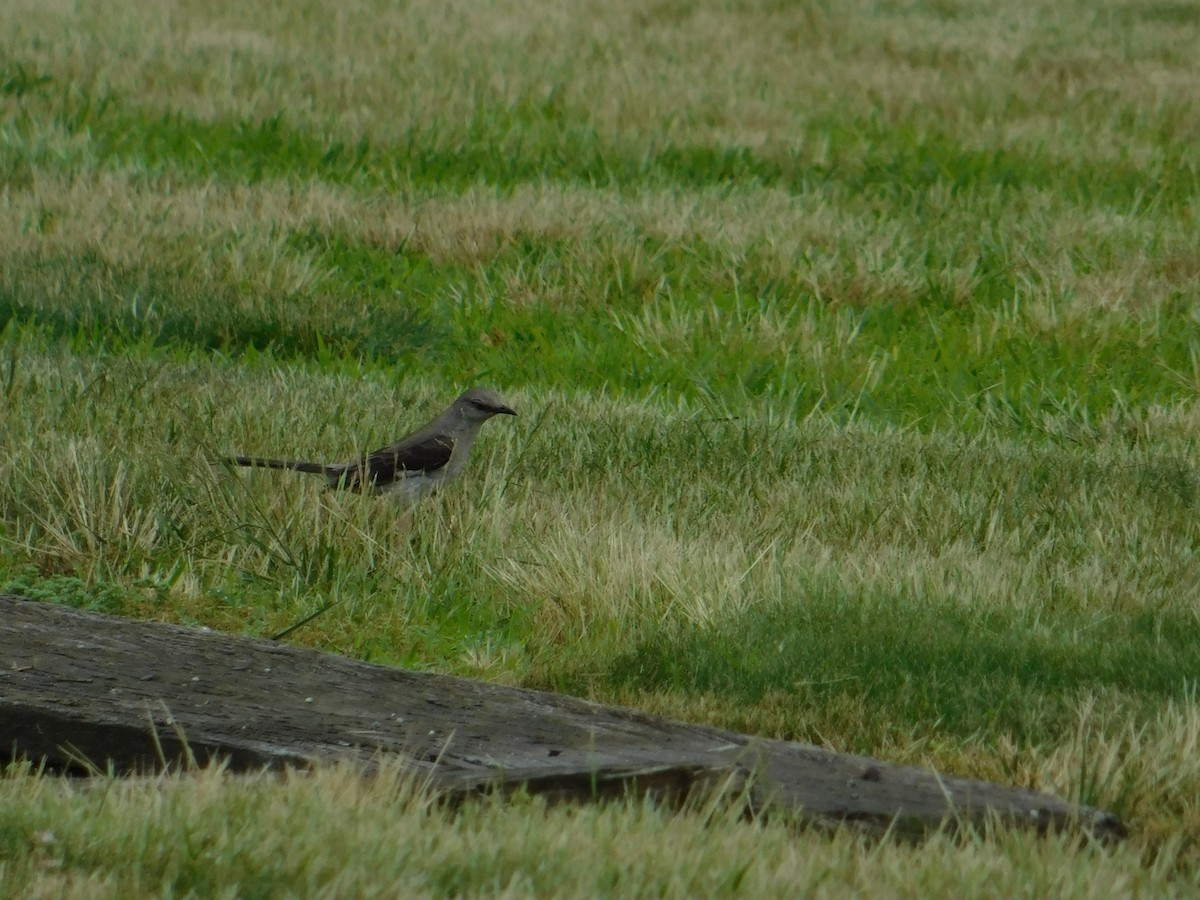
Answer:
xmin=226 ymin=388 xmax=516 ymax=502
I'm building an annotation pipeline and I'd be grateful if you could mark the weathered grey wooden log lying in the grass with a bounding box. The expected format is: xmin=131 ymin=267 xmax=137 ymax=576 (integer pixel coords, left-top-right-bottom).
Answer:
xmin=0 ymin=596 xmax=1126 ymax=839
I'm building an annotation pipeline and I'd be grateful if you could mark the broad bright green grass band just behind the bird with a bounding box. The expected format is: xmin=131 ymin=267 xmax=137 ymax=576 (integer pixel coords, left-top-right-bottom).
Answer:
xmin=0 ymin=208 xmax=1200 ymax=434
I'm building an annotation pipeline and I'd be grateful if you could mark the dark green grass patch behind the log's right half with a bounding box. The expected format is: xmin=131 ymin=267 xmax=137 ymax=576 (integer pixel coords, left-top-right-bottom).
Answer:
xmin=606 ymin=588 xmax=1200 ymax=743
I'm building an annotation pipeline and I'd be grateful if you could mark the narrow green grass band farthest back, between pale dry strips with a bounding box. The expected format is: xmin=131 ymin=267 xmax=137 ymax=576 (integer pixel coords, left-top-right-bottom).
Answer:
xmin=8 ymin=81 xmax=1200 ymax=214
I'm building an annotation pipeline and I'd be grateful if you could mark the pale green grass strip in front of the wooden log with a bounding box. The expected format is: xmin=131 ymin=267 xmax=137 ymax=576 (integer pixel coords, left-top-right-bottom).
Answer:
xmin=0 ymin=770 xmax=1182 ymax=898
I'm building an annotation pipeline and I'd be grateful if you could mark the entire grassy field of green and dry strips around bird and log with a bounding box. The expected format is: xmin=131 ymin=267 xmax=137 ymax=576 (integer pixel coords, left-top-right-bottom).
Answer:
xmin=0 ymin=0 xmax=1200 ymax=898
